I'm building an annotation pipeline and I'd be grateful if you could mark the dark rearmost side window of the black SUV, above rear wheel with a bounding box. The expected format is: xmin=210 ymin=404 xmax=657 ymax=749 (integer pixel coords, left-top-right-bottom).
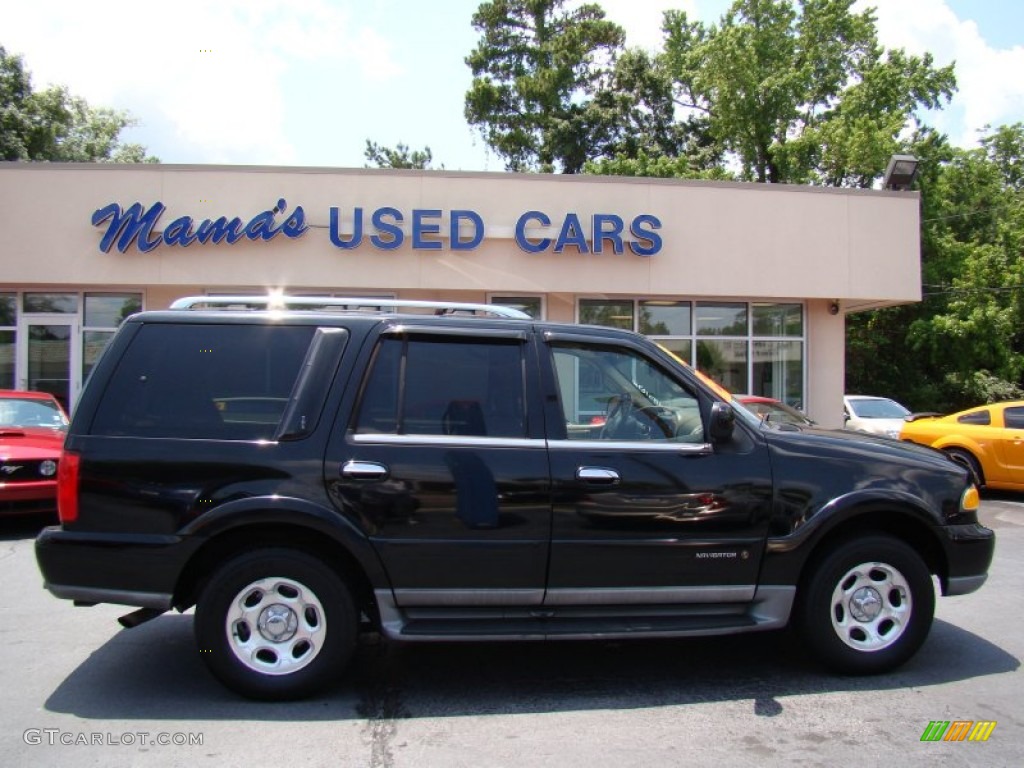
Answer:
xmin=91 ymin=325 xmax=315 ymax=439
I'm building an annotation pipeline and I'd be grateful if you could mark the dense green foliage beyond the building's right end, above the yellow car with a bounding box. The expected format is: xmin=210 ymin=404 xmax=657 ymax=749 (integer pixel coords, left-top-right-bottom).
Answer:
xmin=847 ymin=124 xmax=1024 ymax=412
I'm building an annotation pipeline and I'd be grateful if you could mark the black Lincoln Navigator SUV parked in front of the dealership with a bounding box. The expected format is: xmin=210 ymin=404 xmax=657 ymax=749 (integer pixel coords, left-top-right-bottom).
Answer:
xmin=36 ymin=297 xmax=994 ymax=698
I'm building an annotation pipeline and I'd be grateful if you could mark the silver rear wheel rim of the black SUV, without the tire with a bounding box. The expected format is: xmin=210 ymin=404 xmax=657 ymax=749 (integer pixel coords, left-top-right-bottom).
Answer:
xmin=224 ymin=577 xmax=327 ymax=675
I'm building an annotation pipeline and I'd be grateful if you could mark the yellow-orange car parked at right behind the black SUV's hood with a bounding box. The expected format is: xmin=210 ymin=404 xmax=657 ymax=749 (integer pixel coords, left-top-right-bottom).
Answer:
xmin=899 ymin=400 xmax=1024 ymax=490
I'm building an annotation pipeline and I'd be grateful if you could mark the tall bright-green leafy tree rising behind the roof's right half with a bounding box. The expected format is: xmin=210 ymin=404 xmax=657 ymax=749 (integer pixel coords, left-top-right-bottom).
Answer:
xmin=590 ymin=0 xmax=955 ymax=186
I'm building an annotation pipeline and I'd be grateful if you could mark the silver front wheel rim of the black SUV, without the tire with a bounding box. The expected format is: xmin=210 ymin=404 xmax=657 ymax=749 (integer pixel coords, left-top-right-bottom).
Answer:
xmin=830 ymin=562 xmax=913 ymax=652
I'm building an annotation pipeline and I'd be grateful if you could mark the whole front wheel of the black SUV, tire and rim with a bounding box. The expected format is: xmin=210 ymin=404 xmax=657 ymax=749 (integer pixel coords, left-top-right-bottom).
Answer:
xmin=797 ymin=535 xmax=935 ymax=675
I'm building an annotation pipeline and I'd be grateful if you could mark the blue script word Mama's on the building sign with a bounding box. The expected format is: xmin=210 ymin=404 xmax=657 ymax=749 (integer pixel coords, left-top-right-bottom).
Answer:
xmin=92 ymin=199 xmax=309 ymax=253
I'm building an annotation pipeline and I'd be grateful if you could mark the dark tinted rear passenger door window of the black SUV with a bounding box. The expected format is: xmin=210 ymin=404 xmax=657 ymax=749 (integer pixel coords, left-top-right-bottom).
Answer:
xmin=356 ymin=337 xmax=526 ymax=437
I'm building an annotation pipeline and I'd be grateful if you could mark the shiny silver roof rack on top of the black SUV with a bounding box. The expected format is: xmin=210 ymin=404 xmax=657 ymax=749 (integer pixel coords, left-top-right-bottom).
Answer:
xmin=170 ymin=296 xmax=530 ymax=319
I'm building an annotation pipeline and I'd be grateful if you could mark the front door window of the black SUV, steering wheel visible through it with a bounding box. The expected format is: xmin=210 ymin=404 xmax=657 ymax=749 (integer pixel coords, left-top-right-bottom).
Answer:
xmin=552 ymin=343 xmax=703 ymax=442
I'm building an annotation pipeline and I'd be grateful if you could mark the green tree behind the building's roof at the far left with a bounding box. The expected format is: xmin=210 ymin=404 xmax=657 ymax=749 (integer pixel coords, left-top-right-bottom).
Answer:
xmin=0 ymin=46 xmax=157 ymax=163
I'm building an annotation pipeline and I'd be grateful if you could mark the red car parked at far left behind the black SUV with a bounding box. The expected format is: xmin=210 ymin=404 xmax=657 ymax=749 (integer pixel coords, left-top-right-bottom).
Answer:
xmin=0 ymin=389 xmax=68 ymax=515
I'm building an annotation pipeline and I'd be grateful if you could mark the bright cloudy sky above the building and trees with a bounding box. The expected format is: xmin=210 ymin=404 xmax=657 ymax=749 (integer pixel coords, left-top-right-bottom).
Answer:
xmin=0 ymin=0 xmax=1024 ymax=171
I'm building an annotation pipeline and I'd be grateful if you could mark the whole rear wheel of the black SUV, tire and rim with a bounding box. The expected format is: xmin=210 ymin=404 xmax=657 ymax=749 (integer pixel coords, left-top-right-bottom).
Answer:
xmin=195 ymin=549 xmax=358 ymax=700
